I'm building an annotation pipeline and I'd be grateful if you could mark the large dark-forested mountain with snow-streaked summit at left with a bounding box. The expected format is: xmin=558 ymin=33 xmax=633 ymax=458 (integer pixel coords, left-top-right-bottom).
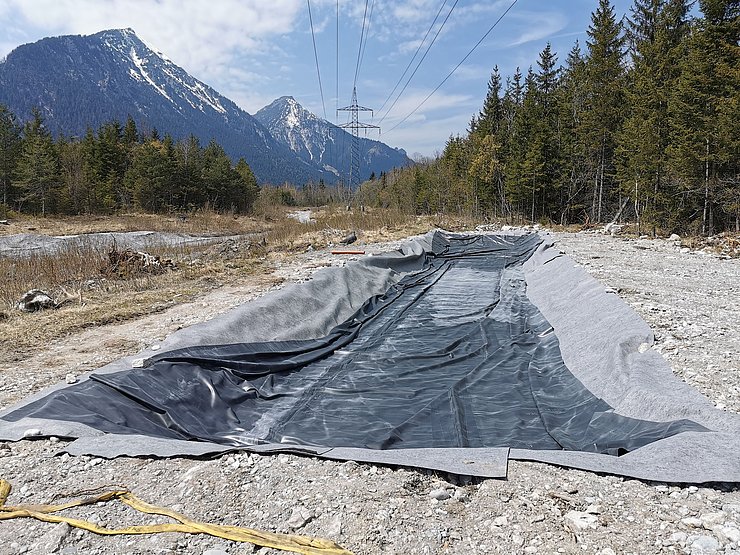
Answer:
xmin=0 ymin=29 xmax=326 ymax=184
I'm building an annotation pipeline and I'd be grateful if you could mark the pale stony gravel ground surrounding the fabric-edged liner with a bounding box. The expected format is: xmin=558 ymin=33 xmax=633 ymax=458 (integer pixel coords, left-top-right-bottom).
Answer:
xmin=0 ymin=228 xmax=740 ymax=555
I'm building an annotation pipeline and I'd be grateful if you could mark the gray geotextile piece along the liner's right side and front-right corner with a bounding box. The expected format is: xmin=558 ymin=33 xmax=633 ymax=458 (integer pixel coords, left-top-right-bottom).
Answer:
xmin=510 ymin=237 xmax=740 ymax=483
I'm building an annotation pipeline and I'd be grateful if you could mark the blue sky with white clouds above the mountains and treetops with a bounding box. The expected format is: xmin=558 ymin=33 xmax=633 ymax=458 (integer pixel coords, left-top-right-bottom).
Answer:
xmin=0 ymin=0 xmax=632 ymax=156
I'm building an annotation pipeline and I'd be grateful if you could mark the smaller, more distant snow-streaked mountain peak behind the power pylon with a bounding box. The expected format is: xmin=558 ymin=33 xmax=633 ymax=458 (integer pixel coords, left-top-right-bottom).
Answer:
xmin=254 ymin=96 xmax=412 ymax=180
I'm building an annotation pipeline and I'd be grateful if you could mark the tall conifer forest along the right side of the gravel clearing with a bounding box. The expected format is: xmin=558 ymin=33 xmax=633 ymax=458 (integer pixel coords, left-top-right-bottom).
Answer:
xmin=359 ymin=0 xmax=740 ymax=234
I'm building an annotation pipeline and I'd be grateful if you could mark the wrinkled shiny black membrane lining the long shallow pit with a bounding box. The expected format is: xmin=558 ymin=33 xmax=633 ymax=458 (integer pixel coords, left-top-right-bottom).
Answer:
xmin=6 ymin=234 xmax=705 ymax=455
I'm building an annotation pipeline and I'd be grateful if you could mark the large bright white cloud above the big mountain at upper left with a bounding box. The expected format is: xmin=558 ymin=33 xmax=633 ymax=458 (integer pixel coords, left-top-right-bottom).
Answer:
xmin=0 ymin=0 xmax=305 ymax=79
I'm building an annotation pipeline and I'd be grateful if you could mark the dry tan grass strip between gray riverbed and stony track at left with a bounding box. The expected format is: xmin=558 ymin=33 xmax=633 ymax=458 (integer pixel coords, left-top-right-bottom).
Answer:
xmin=0 ymin=240 xmax=275 ymax=361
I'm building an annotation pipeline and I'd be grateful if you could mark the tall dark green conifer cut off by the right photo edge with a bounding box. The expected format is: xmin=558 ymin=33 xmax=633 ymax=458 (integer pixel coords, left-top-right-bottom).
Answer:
xmin=669 ymin=0 xmax=740 ymax=234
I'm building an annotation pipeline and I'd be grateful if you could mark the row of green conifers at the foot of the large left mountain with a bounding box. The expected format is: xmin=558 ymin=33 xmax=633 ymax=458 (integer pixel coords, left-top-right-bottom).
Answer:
xmin=0 ymin=109 xmax=259 ymax=215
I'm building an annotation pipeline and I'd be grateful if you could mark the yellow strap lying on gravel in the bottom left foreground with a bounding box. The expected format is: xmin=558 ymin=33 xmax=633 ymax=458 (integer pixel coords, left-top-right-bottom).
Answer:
xmin=0 ymin=478 xmax=352 ymax=555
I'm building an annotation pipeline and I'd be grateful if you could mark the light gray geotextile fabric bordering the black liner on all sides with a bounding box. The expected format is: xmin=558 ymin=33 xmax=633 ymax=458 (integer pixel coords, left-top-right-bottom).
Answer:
xmin=0 ymin=232 xmax=740 ymax=483
